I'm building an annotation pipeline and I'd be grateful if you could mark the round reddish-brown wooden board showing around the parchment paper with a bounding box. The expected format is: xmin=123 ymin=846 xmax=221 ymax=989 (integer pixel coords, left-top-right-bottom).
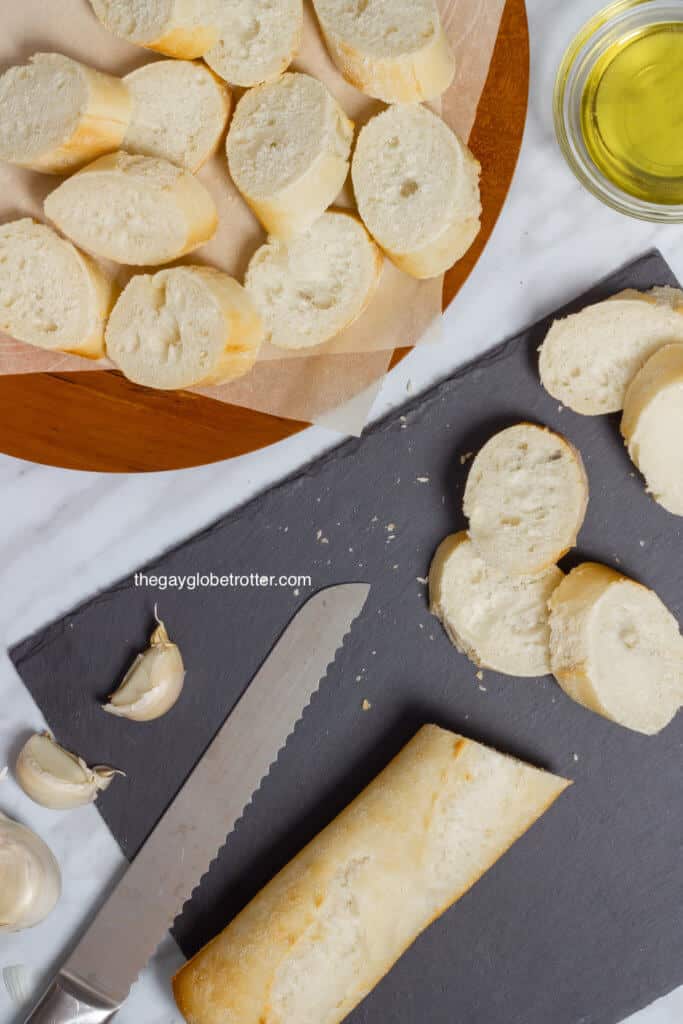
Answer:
xmin=0 ymin=0 xmax=529 ymax=473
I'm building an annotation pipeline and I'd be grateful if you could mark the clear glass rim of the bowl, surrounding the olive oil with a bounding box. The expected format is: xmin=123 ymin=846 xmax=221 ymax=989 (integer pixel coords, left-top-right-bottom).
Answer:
xmin=553 ymin=0 xmax=683 ymax=223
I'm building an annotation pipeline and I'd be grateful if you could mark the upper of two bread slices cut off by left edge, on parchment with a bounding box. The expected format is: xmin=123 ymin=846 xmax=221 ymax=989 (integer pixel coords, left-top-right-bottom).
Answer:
xmin=0 ymin=53 xmax=131 ymax=174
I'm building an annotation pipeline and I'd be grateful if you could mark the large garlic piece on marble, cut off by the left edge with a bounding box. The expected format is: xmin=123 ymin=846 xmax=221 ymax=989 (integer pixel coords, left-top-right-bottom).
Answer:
xmin=0 ymin=813 xmax=61 ymax=932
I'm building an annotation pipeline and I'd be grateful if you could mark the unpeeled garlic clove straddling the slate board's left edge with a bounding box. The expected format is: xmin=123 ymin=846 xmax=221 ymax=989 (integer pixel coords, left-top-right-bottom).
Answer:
xmin=16 ymin=732 xmax=123 ymax=811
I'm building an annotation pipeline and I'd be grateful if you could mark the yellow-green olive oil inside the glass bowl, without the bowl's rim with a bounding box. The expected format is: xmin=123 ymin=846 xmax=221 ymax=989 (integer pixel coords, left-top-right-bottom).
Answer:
xmin=581 ymin=23 xmax=683 ymax=205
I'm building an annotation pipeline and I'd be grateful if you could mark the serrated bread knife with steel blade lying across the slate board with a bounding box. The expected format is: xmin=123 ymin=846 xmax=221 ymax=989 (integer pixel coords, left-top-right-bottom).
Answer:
xmin=26 ymin=584 xmax=370 ymax=1024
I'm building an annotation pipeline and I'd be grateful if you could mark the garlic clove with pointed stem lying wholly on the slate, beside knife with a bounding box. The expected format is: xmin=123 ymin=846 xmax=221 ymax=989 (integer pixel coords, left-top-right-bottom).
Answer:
xmin=104 ymin=609 xmax=185 ymax=722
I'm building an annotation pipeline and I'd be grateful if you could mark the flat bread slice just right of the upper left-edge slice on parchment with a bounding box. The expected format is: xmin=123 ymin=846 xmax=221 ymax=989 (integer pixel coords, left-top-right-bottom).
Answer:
xmin=123 ymin=60 xmax=232 ymax=171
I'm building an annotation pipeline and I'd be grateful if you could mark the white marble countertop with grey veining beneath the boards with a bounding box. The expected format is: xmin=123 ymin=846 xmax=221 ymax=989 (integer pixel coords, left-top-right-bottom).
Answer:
xmin=0 ymin=0 xmax=683 ymax=1024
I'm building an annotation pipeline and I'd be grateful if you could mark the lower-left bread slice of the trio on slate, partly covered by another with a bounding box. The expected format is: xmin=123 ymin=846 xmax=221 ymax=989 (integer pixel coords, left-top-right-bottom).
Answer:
xmin=429 ymin=531 xmax=563 ymax=676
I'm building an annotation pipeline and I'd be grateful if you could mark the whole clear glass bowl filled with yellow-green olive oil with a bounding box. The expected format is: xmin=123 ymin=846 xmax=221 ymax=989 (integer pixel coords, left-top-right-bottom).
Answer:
xmin=554 ymin=0 xmax=683 ymax=222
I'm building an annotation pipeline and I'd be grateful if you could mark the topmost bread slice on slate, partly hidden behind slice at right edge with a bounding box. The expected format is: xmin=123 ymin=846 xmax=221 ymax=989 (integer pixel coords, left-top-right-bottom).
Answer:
xmin=540 ymin=288 xmax=683 ymax=416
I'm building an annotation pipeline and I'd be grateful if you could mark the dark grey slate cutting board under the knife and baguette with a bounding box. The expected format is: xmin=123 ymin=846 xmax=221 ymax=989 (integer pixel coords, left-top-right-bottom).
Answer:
xmin=11 ymin=252 xmax=683 ymax=1024
